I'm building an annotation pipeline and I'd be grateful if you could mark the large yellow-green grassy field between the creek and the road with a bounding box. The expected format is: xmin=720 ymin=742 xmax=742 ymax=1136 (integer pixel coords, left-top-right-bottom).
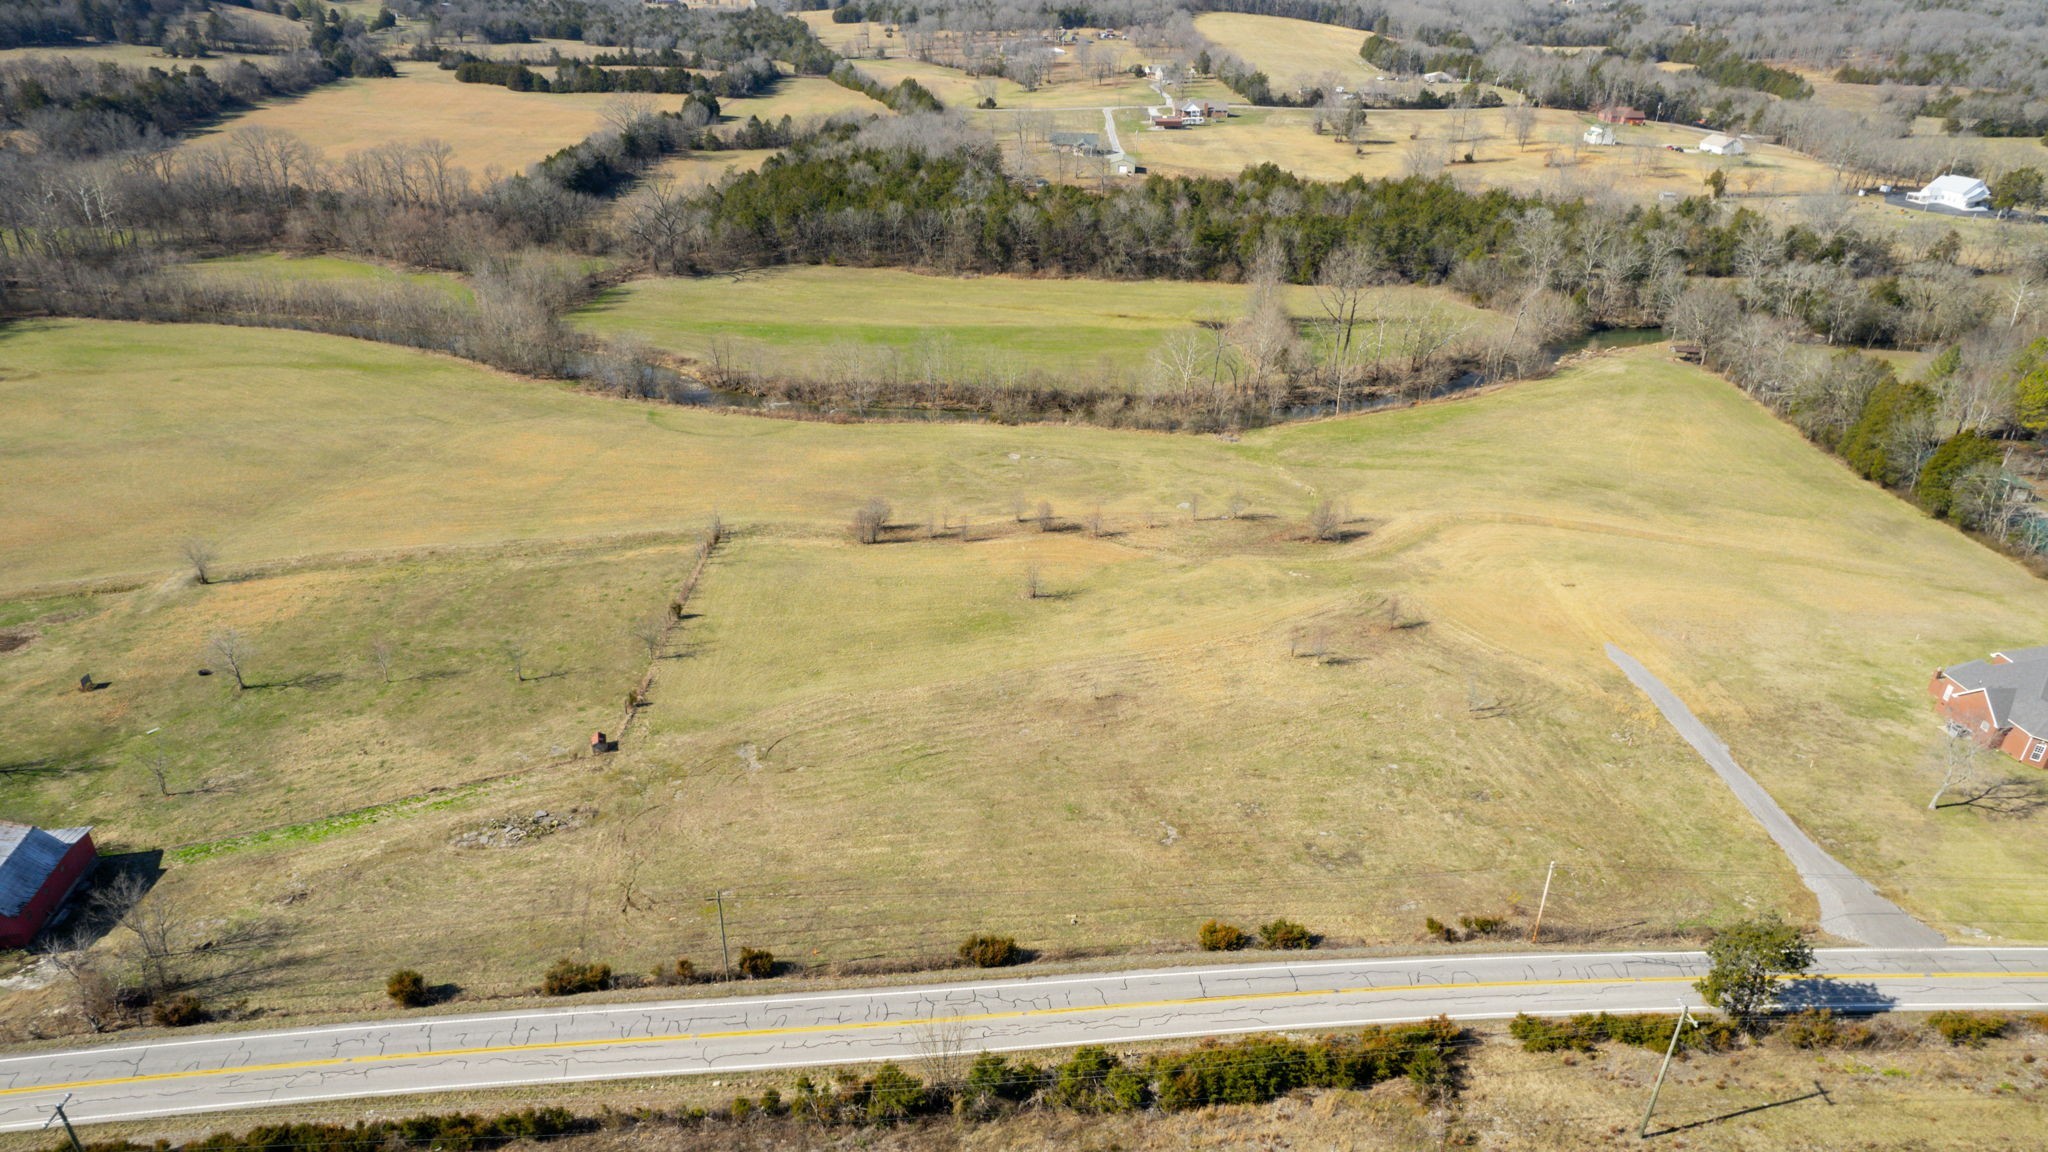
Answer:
xmin=0 ymin=322 xmax=2048 ymax=1015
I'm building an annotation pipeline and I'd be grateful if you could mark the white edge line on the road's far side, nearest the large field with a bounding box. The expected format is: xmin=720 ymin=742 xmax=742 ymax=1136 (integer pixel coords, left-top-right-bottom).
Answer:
xmin=0 ymin=945 xmax=2048 ymax=1065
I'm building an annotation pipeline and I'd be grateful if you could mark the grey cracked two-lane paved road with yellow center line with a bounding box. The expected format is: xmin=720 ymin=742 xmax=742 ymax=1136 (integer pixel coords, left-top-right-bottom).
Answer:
xmin=0 ymin=947 xmax=2048 ymax=1129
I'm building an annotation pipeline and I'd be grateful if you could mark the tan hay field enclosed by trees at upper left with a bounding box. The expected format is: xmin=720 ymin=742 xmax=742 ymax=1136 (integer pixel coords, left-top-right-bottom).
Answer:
xmin=182 ymin=61 xmax=630 ymax=176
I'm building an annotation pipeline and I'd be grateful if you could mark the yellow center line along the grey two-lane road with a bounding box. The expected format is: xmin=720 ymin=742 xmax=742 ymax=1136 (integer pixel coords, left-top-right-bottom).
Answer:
xmin=0 ymin=972 xmax=2048 ymax=1097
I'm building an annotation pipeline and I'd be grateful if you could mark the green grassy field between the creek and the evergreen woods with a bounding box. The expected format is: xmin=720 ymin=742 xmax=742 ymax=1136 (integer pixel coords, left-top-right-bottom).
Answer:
xmin=582 ymin=266 xmax=1501 ymax=383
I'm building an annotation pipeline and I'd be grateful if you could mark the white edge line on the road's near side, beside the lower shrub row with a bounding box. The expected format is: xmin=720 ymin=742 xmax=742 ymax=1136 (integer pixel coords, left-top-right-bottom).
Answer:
xmin=0 ymin=1000 xmax=2040 ymax=1132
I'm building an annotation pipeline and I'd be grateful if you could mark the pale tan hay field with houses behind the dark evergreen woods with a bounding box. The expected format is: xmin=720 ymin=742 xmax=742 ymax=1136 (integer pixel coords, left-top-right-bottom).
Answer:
xmin=1116 ymin=109 xmax=1833 ymax=199
